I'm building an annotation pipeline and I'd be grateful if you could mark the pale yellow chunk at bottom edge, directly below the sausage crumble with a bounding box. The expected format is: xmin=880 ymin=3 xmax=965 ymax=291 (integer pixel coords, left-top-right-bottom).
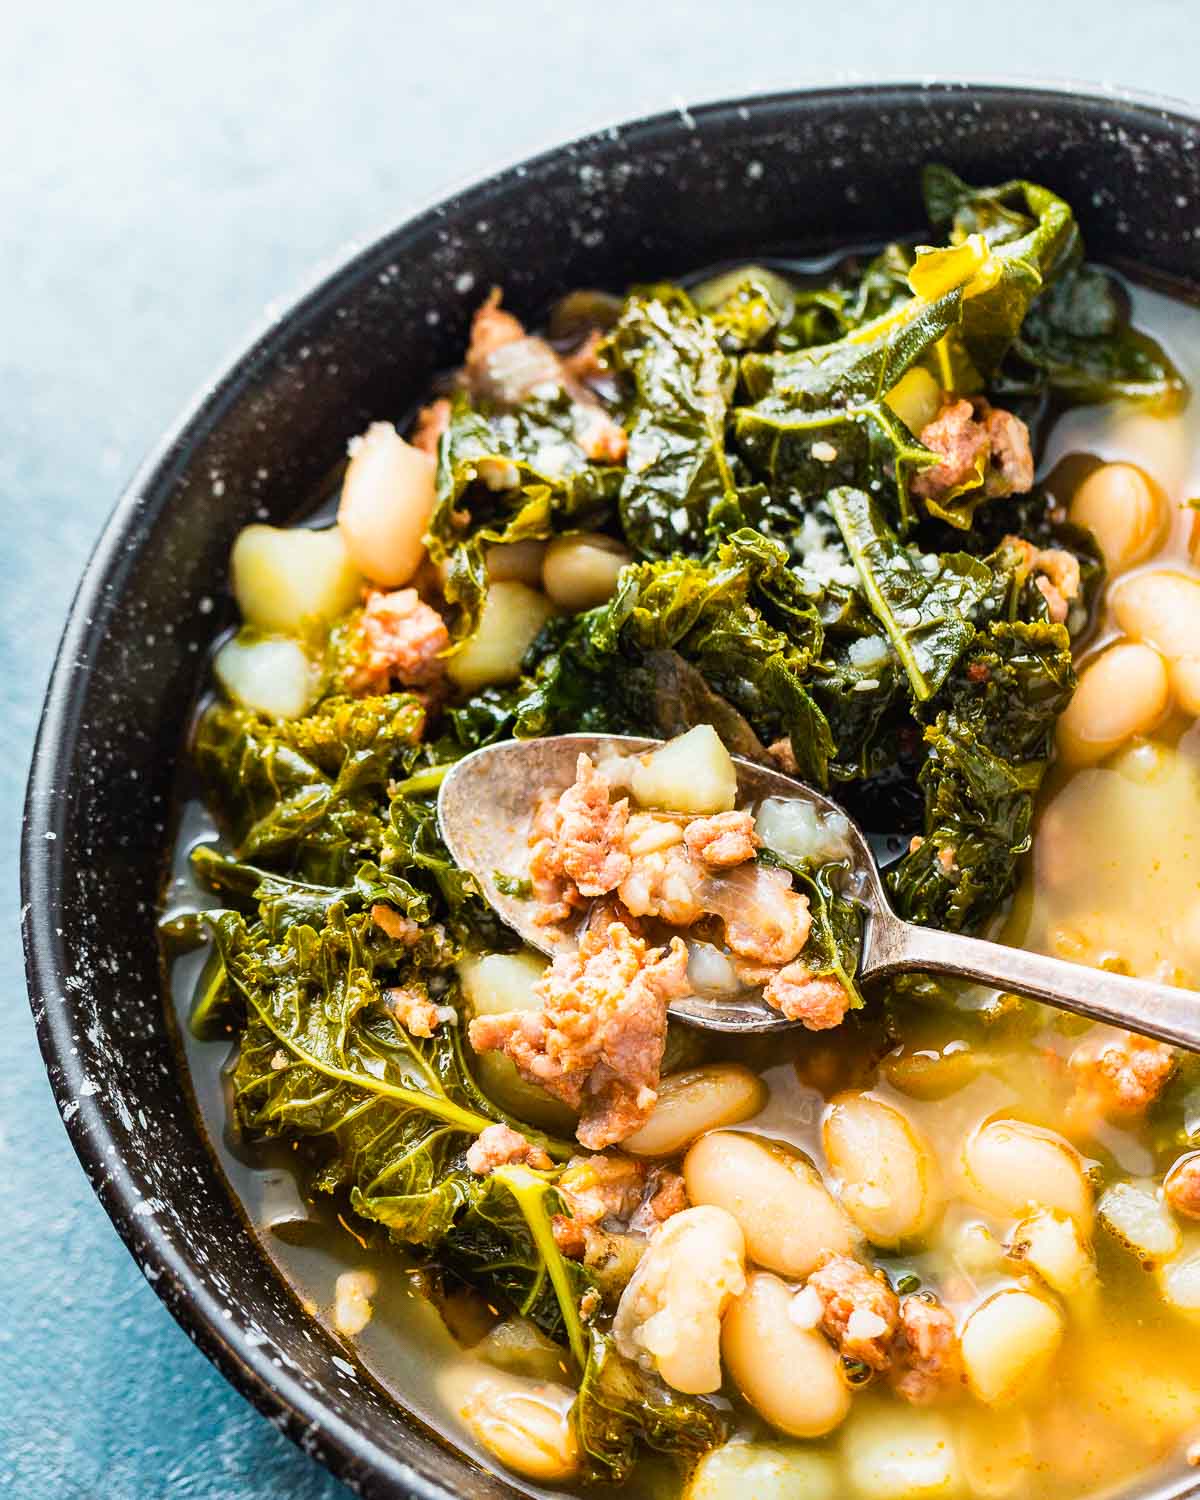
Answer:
xmin=840 ymin=1400 xmax=963 ymax=1500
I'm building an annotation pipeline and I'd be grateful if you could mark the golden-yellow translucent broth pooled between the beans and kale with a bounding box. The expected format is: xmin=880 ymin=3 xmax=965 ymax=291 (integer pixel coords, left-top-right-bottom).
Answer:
xmin=168 ymin=273 xmax=1200 ymax=1500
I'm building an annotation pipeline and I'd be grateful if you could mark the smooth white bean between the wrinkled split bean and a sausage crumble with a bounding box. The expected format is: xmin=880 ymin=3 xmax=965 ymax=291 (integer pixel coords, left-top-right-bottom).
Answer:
xmin=722 ymin=1271 xmax=851 ymax=1437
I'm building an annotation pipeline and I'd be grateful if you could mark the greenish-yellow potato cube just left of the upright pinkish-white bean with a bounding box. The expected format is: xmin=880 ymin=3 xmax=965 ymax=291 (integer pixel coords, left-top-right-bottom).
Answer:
xmin=230 ymin=527 xmax=363 ymax=635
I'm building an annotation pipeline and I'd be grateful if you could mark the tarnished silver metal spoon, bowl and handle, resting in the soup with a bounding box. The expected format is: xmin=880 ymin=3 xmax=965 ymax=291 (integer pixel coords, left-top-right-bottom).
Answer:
xmin=438 ymin=735 xmax=1200 ymax=1050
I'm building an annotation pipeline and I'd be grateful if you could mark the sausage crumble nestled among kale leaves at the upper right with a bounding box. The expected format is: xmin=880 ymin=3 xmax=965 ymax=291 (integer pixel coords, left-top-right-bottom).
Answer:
xmin=912 ymin=396 xmax=1034 ymax=501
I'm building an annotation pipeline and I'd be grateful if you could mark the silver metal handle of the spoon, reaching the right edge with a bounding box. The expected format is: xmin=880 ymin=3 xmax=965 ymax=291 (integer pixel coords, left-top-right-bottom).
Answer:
xmin=863 ymin=918 xmax=1200 ymax=1052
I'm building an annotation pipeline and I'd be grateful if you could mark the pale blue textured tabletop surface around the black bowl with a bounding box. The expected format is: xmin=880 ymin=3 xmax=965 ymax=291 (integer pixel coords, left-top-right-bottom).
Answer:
xmin=0 ymin=0 xmax=1200 ymax=1500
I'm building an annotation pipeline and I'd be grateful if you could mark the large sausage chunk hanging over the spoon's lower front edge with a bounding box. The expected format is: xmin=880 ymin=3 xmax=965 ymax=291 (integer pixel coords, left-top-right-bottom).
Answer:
xmin=470 ymin=923 xmax=692 ymax=1151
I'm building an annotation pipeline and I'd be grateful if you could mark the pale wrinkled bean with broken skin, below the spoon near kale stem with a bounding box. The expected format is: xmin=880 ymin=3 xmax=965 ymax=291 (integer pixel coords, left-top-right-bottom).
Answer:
xmin=612 ymin=1206 xmax=746 ymax=1395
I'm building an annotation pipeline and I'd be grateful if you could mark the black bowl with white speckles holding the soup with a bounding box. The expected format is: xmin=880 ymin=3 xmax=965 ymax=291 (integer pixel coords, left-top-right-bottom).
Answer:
xmin=23 ymin=84 xmax=1200 ymax=1500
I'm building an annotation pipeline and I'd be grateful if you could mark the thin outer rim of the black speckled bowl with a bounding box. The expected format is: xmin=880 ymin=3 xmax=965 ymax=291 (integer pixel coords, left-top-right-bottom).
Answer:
xmin=20 ymin=77 xmax=1200 ymax=1500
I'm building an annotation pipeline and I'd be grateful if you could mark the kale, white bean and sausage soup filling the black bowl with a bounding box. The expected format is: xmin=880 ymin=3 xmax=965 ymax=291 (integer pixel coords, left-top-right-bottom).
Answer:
xmin=164 ymin=170 xmax=1200 ymax=1500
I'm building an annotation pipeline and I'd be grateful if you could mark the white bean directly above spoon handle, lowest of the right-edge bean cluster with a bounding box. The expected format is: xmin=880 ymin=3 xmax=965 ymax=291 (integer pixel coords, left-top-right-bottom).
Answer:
xmin=1058 ymin=641 xmax=1170 ymax=765
